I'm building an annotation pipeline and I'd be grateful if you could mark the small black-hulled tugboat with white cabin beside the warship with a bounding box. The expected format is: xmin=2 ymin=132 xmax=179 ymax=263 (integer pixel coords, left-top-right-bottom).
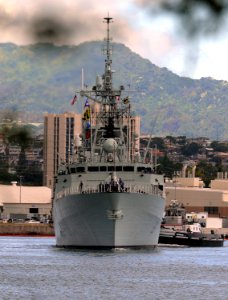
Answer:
xmin=159 ymin=200 xmax=224 ymax=247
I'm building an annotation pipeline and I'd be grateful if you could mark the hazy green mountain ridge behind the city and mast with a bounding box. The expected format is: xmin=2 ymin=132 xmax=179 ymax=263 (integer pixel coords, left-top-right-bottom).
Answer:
xmin=0 ymin=42 xmax=228 ymax=140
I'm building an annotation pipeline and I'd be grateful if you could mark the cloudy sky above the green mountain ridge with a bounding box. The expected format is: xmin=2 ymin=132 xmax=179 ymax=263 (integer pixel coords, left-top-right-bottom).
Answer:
xmin=0 ymin=0 xmax=228 ymax=81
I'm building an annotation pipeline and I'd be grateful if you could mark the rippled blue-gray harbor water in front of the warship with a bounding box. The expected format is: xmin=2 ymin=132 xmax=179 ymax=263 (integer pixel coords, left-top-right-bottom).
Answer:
xmin=0 ymin=236 xmax=228 ymax=300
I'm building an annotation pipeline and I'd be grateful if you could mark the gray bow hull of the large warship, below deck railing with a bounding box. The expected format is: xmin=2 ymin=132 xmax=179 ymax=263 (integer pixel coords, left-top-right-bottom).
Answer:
xmin=53 ymin=193 xmax=165 ymax=248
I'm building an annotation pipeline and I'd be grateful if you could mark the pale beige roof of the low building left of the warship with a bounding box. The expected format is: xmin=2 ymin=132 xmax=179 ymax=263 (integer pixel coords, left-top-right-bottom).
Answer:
xmin=0 ymin=184 xmax=52 ymax=205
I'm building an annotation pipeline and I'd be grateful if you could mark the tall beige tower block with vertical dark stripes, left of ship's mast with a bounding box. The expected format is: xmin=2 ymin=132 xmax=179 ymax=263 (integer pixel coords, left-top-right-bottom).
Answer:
xmin=43 ymin=112 xmax=81 ymax=188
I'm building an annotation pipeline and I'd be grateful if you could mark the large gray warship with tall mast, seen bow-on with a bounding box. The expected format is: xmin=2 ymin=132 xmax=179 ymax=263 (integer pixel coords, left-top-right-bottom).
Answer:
xmin=53 ymin=16 xmax=165 ymax=248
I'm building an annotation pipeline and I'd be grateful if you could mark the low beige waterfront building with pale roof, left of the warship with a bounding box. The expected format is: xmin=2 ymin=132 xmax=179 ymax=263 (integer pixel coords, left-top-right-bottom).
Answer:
xmin=0 ymin=182 xmax=52 ymax=219
